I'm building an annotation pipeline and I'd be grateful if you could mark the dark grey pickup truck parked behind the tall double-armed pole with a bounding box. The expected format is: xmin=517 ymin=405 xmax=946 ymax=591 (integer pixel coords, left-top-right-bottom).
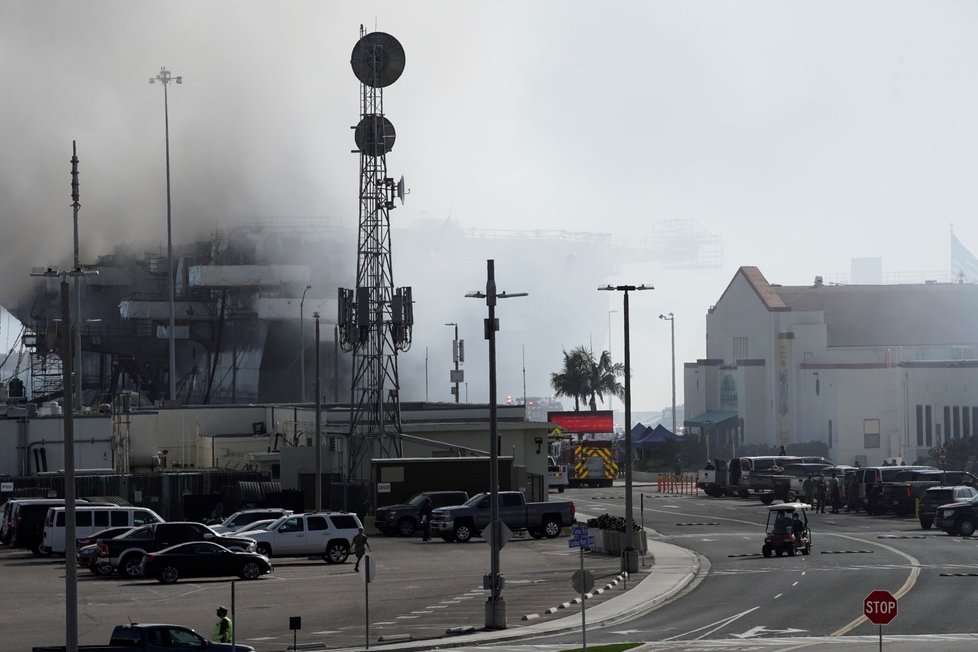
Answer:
xmin=431 ymin=491 xmax=576 ymax=543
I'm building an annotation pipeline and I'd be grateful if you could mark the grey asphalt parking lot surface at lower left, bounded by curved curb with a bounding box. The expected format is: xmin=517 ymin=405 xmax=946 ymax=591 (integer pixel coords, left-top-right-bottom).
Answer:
xmin=0 ymin=536 xmax=640 ymax=651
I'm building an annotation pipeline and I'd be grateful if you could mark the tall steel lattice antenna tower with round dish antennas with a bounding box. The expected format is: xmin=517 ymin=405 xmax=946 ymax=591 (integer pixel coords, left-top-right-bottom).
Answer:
xmin=337 ymin=25 xmax=414 ymax=483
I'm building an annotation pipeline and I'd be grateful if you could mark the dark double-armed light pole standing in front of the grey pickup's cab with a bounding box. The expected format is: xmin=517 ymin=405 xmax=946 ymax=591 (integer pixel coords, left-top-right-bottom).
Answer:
xmin=465 ymin=259 xmax=527 ymax=629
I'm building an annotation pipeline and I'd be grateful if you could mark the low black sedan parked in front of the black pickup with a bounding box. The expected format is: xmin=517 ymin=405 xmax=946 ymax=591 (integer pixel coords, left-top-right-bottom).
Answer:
xmin=142 ymin=541 xmax=272 ymax=584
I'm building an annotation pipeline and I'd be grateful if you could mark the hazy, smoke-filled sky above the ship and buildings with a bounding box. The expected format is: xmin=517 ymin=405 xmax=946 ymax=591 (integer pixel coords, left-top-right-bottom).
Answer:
xmin=0 ymin=0 xmax=978 ymax=409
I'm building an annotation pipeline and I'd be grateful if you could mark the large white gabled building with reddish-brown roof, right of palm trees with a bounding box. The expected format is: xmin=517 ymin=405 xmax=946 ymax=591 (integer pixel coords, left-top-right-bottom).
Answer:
xmin=684 ymin=267 xmax=978 ymax=465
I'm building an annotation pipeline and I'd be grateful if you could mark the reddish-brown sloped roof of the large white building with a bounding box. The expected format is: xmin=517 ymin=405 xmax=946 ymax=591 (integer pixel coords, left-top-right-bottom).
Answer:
xmin=737 ymin=267 xmax=978 ymax=346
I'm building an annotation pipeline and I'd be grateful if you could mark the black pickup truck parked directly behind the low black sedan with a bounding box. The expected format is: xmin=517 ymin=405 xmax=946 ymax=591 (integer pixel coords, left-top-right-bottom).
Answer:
xmin=95 ymin=521 xmax=257 ymax=578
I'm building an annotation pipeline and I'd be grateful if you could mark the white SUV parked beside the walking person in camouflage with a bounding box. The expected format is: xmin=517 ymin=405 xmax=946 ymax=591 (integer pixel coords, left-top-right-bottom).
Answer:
xmin=240 ymin=512 xmax=363 ymax=564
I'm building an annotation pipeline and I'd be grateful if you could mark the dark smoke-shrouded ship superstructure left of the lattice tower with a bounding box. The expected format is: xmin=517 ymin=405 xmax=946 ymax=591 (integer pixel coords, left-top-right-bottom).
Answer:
xmin=15 ymin=219 xmax=353 ymax=408
